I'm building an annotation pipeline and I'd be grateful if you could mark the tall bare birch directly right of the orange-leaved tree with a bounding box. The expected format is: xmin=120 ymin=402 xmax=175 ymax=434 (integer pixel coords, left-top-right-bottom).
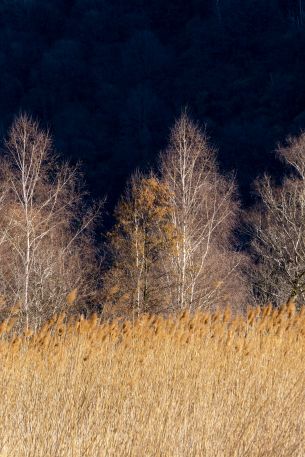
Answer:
xmin=161 ymin=113 xmax=245 ymax=310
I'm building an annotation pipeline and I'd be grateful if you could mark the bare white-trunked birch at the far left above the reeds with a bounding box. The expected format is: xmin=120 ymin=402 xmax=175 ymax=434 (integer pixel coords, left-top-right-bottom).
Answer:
xmin=0 ymin=115 xmax=101 ymax=327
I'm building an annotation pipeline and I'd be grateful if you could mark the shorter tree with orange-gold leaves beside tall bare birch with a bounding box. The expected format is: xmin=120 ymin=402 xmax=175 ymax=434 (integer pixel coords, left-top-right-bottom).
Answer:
xmin=104 ymin=174 xmax=177 ymax=317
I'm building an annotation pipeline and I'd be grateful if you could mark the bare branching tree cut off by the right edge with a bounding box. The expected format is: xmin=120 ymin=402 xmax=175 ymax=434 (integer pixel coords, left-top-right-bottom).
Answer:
xmin=248 ymin=133 xmax=305 ymax=305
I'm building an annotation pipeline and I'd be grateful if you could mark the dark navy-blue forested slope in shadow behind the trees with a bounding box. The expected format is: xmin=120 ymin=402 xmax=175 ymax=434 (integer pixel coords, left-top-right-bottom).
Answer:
xmin=0 ymin=0 xmax=305 ymax=216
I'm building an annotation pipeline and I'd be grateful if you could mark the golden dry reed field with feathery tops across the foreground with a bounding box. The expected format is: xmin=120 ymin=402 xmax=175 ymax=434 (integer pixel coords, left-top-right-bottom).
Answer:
xmin=0 ymin=305 xmax=305 ymax=457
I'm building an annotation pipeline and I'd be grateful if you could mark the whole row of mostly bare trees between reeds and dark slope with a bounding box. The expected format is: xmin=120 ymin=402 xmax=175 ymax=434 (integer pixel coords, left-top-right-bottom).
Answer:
xmin=0 ymin=112 xmax=305 ymax=327
